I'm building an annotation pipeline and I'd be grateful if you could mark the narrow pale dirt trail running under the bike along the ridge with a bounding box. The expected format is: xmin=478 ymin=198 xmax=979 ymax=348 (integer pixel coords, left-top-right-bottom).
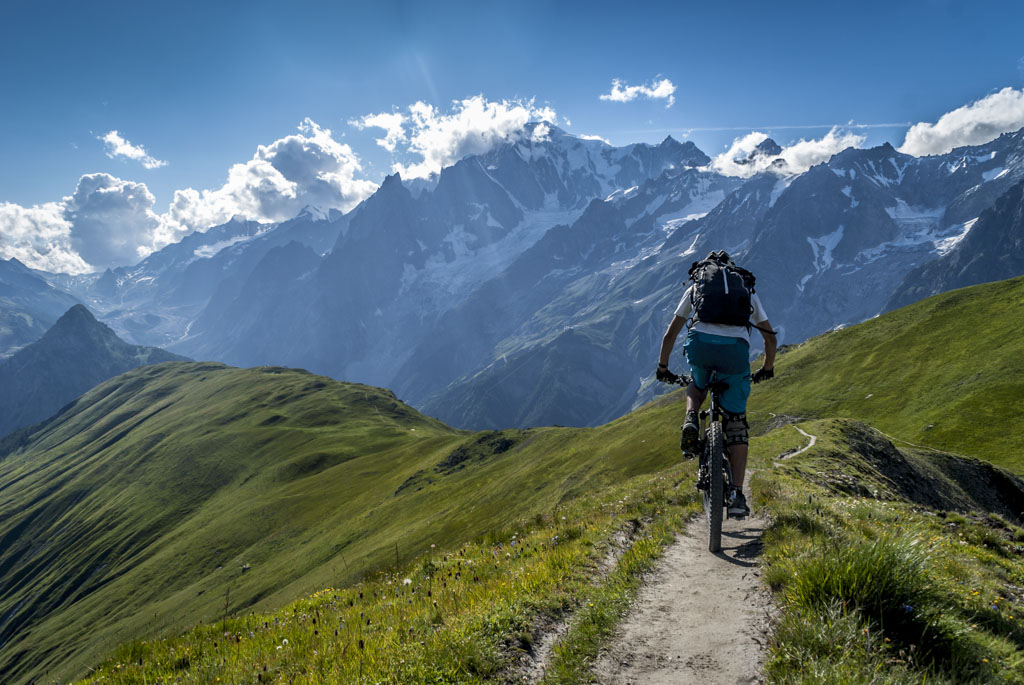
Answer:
xmin=594 ymin=426 xmax=817 ymax=685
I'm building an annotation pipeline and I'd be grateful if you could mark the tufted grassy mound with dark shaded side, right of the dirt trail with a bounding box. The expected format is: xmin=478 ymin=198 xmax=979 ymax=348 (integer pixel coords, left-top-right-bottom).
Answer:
xmin=752 ymin=420 xmax=1024 ymax=684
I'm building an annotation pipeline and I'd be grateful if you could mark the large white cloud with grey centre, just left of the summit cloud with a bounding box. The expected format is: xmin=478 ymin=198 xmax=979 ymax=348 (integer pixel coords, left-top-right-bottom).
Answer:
xmin=166 ymin=118 xmax=377 ymax=232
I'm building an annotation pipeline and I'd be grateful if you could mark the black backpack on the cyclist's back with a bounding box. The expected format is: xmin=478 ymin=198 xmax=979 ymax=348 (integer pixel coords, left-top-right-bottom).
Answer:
xmin=689 ymin=250 xmax=755 ymax=329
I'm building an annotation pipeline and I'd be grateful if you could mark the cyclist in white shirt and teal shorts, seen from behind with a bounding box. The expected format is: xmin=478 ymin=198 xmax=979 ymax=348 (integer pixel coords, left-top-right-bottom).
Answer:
xmin=656 ymin=251 xmax=777 ymax=516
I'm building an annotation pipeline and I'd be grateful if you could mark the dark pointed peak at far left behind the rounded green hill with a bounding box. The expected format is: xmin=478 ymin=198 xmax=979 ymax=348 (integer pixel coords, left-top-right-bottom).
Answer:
xmin=0 ymin=304 xmax=186 ymax=437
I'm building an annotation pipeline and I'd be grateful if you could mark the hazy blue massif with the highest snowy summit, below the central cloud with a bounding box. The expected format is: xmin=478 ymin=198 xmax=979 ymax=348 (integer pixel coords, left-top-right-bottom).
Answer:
xmin=174 ymin=125 xmax=716 ymax=385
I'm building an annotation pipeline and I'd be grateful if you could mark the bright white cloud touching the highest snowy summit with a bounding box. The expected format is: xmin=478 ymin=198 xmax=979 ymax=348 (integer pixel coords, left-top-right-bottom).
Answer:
xmin=353 ymin=95 xmax=557 ymax=178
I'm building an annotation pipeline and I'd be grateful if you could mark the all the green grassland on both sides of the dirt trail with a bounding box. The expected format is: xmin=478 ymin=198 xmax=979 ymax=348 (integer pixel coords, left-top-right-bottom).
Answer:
xmin=0 ymin=279 xmax=1024 ymax=683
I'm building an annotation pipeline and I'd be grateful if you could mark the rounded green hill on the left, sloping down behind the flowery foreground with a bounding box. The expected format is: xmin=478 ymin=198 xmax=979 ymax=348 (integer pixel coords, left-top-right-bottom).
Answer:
xmin=0 ymin=363 xmax=696 ymax=680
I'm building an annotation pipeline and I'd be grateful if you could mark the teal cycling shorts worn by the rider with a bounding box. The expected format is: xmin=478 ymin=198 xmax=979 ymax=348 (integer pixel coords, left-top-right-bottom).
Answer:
xmin=683 ymin=331 xmax=751 ymax=414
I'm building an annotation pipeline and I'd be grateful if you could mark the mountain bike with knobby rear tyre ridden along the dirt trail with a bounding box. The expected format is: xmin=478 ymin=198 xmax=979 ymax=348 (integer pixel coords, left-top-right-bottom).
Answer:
xmin=663 ymin=371 xmax=743 ymax=552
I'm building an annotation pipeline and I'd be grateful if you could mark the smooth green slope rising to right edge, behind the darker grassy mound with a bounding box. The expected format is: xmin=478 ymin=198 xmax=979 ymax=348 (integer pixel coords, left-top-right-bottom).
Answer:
xmin=752 ymin=277 xmax=1024 ymax=473
